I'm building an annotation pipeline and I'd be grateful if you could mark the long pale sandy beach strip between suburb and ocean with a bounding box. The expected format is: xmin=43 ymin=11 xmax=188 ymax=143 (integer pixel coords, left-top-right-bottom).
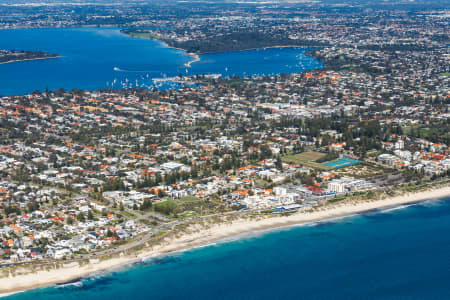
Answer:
xmin=0 ymin=186 xmax=450 ymax=294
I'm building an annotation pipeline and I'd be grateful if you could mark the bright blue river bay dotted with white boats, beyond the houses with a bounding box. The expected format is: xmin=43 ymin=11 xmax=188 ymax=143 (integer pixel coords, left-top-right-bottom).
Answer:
xmin=0 ymin=28 xmax=323 ymax=95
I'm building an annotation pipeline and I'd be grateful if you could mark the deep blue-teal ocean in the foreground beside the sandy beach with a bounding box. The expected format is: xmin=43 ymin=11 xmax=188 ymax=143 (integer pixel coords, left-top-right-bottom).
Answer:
xmin=0 ymin=198 xmax=450 ymax=300
